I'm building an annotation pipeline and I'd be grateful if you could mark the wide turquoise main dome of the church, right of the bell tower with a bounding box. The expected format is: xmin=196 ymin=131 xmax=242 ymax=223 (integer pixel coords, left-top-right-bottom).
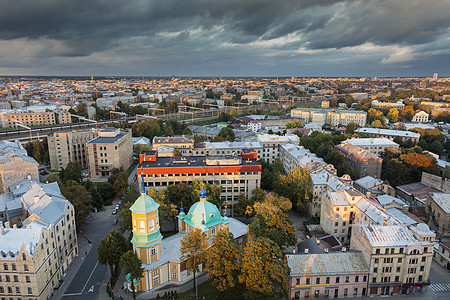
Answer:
xmin=184 ymin=201 xmax=222 ymax=228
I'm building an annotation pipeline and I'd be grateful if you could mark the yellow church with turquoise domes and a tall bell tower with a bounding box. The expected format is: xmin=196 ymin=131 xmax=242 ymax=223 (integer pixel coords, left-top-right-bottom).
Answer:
xmin=128 ymin=179 xmax=248 ymax=296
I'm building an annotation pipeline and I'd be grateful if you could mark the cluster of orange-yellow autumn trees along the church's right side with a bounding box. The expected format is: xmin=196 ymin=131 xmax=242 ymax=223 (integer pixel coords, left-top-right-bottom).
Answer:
xmin=180 ymin=192 xmax=296 ymax=298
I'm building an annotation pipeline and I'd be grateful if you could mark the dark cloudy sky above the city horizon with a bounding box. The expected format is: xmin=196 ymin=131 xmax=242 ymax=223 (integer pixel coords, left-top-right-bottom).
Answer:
xmin=0 ymin=0 xmax=450 ymax=76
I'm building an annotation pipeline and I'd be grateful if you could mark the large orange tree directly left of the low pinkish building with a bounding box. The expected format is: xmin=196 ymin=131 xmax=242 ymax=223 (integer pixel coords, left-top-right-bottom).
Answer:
xmin=238 ymin=238 xmax=289 ymax=297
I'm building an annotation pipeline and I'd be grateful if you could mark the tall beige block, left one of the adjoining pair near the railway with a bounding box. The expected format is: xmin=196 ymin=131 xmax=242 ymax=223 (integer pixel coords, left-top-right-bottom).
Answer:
xmin=47 ymin=129 xmax=98 ymax=171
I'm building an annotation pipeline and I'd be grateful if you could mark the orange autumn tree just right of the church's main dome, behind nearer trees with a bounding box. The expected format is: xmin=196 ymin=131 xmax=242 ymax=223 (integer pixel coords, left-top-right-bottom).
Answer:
xmin=249 ymin=201 xmax=297 ymax=249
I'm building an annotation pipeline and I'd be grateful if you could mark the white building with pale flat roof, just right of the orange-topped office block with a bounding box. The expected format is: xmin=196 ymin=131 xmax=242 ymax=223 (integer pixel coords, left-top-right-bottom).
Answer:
xmin=257 ymin=134 xmax=300 ymax=163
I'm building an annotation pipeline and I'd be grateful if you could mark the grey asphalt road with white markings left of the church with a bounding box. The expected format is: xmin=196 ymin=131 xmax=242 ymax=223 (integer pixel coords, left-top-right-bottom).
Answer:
xmin=62 ymin=201 xmax=117 ymax=300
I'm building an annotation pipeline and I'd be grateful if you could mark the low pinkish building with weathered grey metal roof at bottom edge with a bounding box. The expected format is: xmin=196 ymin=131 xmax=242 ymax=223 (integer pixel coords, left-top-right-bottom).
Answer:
xmin=286 ymin=251 xmax=369 ymax=299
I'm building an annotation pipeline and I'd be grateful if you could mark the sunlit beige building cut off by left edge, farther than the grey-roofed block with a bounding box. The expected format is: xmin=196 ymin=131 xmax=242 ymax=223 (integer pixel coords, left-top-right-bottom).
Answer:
xmin=0 ymin=141 xmax=39 ymax=193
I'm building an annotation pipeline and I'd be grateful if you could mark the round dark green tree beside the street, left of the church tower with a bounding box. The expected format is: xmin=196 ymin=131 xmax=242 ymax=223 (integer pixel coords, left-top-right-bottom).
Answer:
xmin=97 ymin=230 xmax=128 ymax=277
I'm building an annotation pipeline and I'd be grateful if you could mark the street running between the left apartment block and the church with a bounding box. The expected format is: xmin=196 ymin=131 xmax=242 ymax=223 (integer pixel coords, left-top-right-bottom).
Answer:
xmin=53 ymin=198 xmax=118 ymax=300
